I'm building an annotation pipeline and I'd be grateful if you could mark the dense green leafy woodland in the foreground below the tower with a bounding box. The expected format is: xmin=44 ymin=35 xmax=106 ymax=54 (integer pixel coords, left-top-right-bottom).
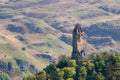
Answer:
xmin=24 ymin=52 xmax=120 ymax=80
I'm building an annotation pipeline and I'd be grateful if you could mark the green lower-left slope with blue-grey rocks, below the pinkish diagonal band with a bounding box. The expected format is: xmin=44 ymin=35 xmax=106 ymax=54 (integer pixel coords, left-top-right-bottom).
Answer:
xmin=0 ymin=43 xmax=49 ymax=80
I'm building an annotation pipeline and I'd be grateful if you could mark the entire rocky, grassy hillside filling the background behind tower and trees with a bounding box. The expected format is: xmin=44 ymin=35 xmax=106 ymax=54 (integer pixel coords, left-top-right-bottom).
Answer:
xmin=0 ymin=0 xmax=120 ymax=77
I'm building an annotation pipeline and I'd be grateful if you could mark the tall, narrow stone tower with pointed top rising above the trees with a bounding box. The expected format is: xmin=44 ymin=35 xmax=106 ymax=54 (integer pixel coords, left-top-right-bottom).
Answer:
xmin=71 ymin=24 xmax=85 ymax=59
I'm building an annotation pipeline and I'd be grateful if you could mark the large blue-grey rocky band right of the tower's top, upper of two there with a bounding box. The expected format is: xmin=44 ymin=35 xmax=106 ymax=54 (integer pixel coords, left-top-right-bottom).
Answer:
xmin=84 ymin=23 xmax=120 ymax=41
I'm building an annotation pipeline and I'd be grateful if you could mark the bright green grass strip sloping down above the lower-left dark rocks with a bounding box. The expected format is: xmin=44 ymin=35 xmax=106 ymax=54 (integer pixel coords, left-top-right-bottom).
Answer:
xmin=0 ymin=43 xmax=48 ymax=69
